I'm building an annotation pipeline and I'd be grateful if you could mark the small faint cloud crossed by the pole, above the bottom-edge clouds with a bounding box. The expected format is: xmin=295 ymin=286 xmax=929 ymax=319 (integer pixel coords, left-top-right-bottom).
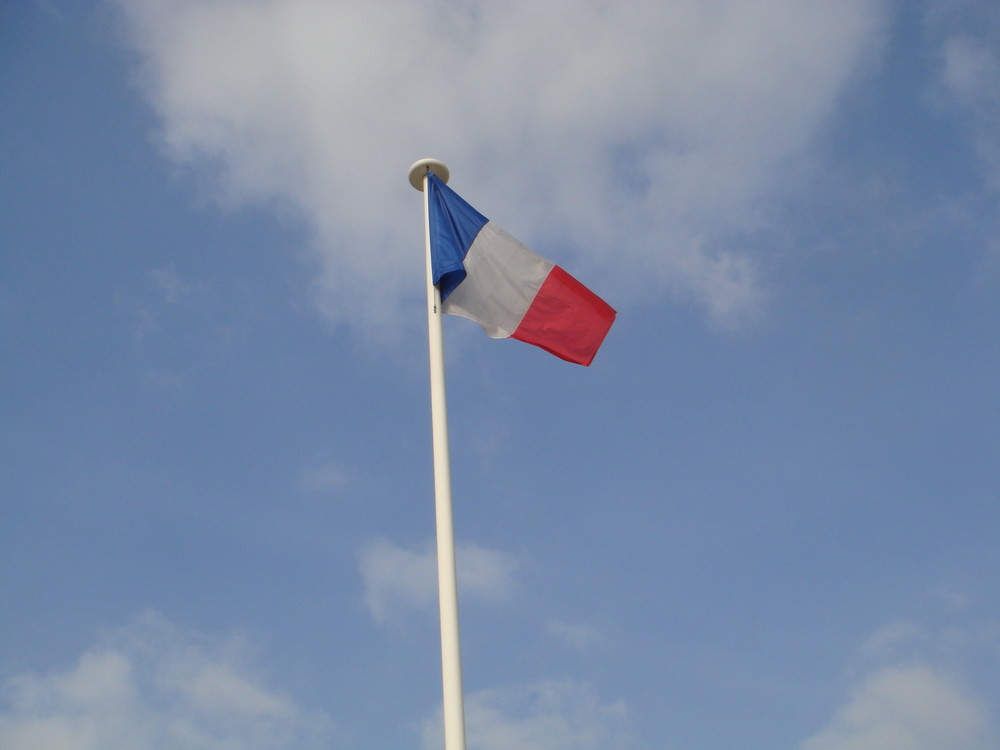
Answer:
xmin=360 ymin=539 xmax=518 ymax=623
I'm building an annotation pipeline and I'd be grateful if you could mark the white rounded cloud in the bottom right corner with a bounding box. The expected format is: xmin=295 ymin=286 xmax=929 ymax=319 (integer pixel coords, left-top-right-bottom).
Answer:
xmin=801 ymin=664 xmax=997 ymax=750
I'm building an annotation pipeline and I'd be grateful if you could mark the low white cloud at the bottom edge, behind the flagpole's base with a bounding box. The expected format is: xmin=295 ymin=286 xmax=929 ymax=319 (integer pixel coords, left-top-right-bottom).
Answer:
xmin=423 ymin=681 xmax=632 ymax=750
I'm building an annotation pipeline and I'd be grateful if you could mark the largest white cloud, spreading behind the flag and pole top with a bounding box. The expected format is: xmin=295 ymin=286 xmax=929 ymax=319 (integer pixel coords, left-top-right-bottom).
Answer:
xmin=118 ymin=0 xmax=883 ymax=329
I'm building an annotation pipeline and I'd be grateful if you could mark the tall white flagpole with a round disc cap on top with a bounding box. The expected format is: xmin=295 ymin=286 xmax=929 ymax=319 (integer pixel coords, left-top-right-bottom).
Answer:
xmin=409 ymin=159 xmax=465 ymax=750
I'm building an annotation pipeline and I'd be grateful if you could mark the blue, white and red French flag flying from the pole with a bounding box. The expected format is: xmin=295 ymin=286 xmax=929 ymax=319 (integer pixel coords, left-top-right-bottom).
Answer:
xmin=427 ymin=173 xmax=615 ymax=365
